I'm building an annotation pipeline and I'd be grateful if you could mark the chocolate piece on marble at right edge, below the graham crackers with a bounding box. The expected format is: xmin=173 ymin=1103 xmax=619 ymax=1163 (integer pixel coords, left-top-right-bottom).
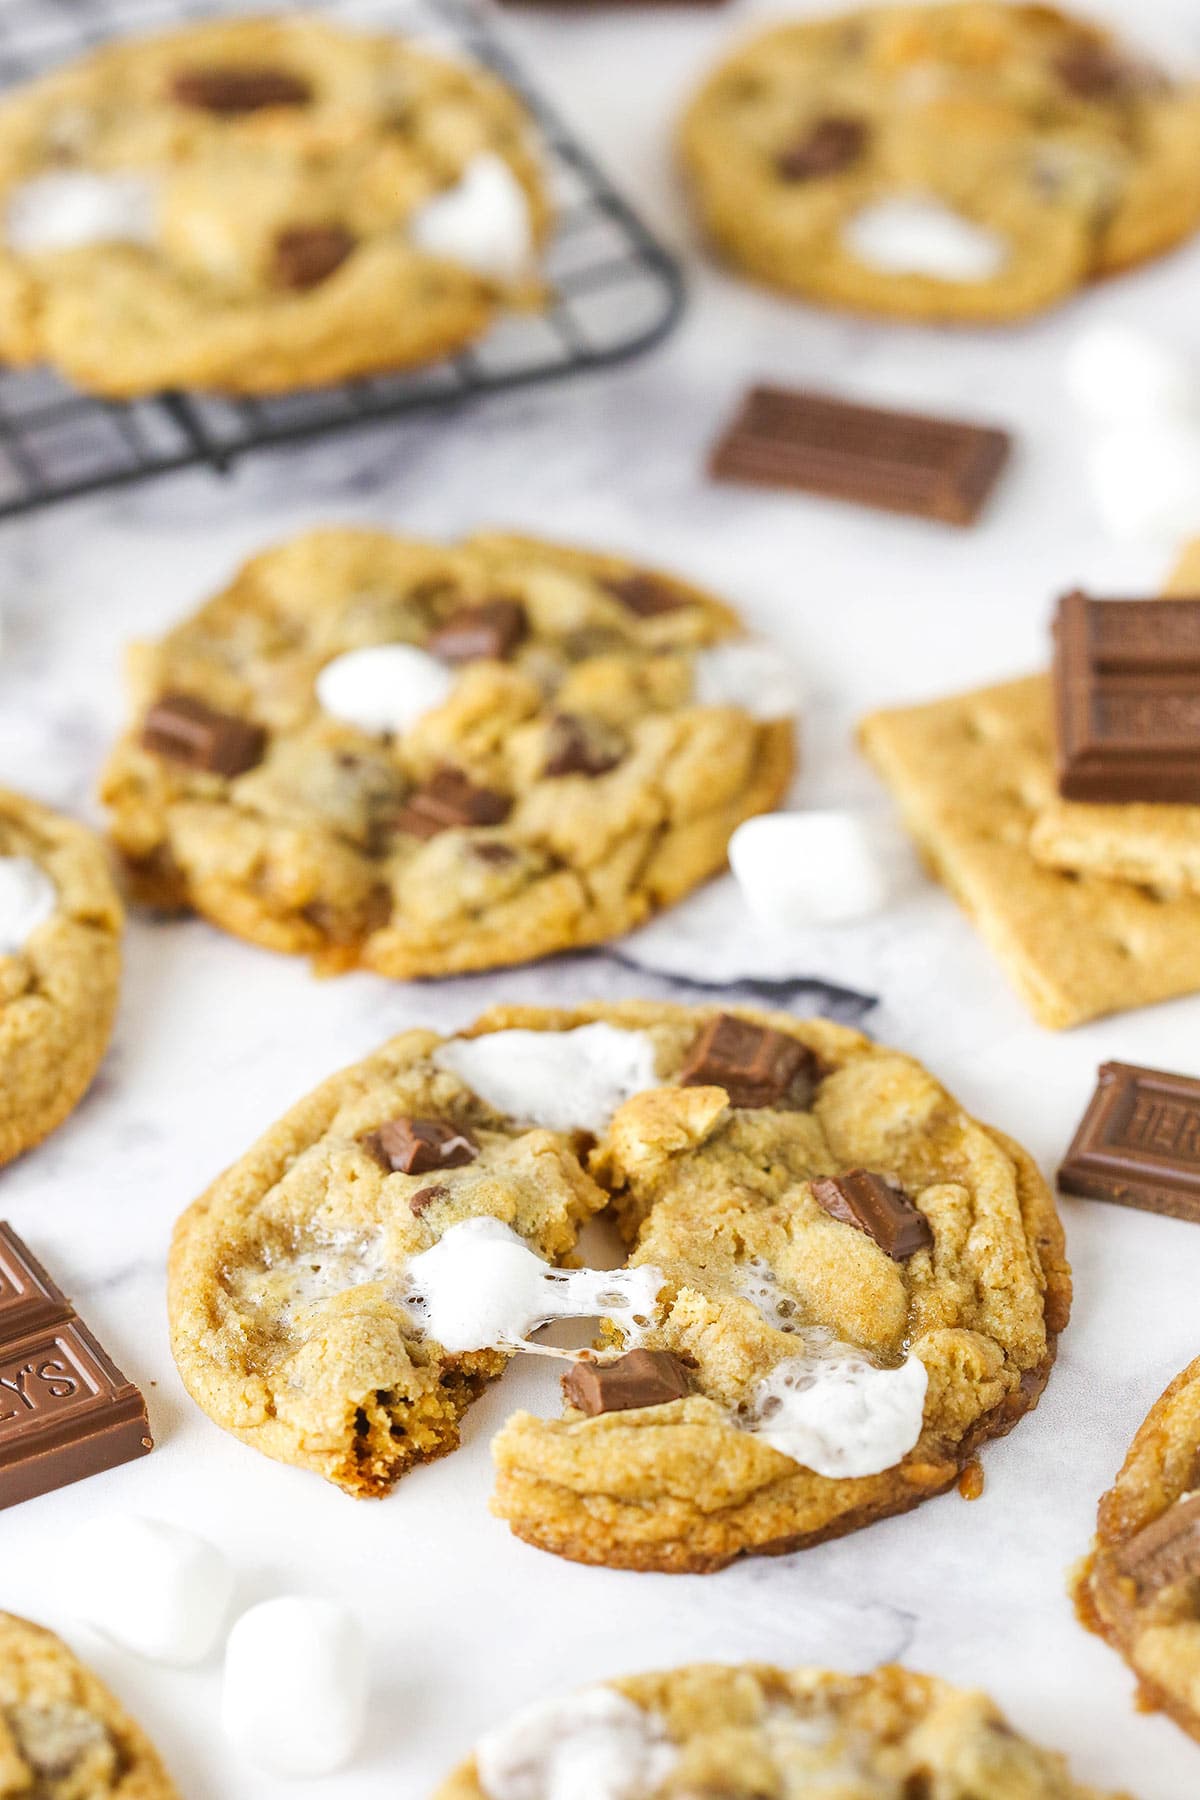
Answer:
xmin=1058 ymin=1062 xmax=1200 ymax=1222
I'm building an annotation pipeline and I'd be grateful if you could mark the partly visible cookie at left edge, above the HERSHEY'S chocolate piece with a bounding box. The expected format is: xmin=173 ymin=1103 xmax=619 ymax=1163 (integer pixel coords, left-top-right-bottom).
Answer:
xmin=0 ymin=788 xmax=124 ymax=1163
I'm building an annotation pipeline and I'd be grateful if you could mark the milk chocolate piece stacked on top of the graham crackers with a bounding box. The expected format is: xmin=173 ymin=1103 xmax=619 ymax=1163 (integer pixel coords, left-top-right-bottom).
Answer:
xmin=1054 ymin=590 xmax=1200 ymax=805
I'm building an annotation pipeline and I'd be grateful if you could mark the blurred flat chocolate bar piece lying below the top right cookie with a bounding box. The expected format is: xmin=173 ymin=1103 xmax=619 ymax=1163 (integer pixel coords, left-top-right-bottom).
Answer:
xmin=709 ymin=387 xmax=1009 ymax=526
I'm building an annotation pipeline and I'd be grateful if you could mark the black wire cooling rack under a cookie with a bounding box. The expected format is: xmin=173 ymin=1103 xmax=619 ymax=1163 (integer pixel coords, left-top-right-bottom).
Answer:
xmin=0 ymin=0 xmax=684 ymax=518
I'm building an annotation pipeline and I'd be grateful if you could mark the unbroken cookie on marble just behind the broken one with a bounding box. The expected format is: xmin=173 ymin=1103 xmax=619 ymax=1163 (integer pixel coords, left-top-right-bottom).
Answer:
xmin=104 ymin=529 xmax=793 ymax=977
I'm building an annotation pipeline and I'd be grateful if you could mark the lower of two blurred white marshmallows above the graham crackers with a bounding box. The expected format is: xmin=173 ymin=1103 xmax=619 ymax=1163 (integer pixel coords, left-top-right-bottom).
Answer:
xmin=1088 ymin=419 xmax=1200 ymax=544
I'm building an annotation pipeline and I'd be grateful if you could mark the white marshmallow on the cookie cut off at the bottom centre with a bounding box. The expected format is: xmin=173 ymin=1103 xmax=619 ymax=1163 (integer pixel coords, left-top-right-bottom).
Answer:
xmin=475 ymin=1687 xmax=678 ymax=1800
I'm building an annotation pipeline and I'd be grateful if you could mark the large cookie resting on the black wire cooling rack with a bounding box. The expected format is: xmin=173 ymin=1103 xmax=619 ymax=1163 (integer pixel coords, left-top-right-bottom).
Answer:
xmin=0 ymin=16 xmax=549 ymax=396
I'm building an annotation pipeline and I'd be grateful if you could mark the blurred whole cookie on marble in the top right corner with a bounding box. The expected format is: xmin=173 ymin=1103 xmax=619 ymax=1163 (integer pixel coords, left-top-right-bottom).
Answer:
xmin=680 ymin=0 xmax=1200 ymax=324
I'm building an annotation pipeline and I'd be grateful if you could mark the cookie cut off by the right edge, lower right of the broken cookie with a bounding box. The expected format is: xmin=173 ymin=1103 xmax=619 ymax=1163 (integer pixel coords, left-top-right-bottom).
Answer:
xmin=1076 ymin=1359 xmax=1200 ymax=1739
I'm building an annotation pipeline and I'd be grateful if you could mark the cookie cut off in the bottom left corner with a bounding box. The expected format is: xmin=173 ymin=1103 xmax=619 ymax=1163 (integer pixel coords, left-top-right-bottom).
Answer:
xmin=0 ymin=1613 xmax=178 ymax=1800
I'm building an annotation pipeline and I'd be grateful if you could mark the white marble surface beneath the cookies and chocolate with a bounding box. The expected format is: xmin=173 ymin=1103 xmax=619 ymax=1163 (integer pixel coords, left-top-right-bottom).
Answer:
xmin=0 ymin=0 xmax=1200 ymax=1800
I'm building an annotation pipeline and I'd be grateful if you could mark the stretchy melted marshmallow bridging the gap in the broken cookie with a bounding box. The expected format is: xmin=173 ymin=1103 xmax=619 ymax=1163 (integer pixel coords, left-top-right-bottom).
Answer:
xmin=403 ymin=1219 xmax=664 ymax=1354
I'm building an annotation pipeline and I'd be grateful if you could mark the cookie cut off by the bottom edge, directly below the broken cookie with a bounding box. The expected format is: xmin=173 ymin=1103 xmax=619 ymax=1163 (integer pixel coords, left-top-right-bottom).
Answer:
xmin=434 ymin=1663 xmax=1128 ymax=1800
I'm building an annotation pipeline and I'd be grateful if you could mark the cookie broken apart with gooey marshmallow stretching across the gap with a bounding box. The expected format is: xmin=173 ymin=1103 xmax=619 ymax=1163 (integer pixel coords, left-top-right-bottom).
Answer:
xmin=169 ymin=1003 xmax=1070 ymax=1571
